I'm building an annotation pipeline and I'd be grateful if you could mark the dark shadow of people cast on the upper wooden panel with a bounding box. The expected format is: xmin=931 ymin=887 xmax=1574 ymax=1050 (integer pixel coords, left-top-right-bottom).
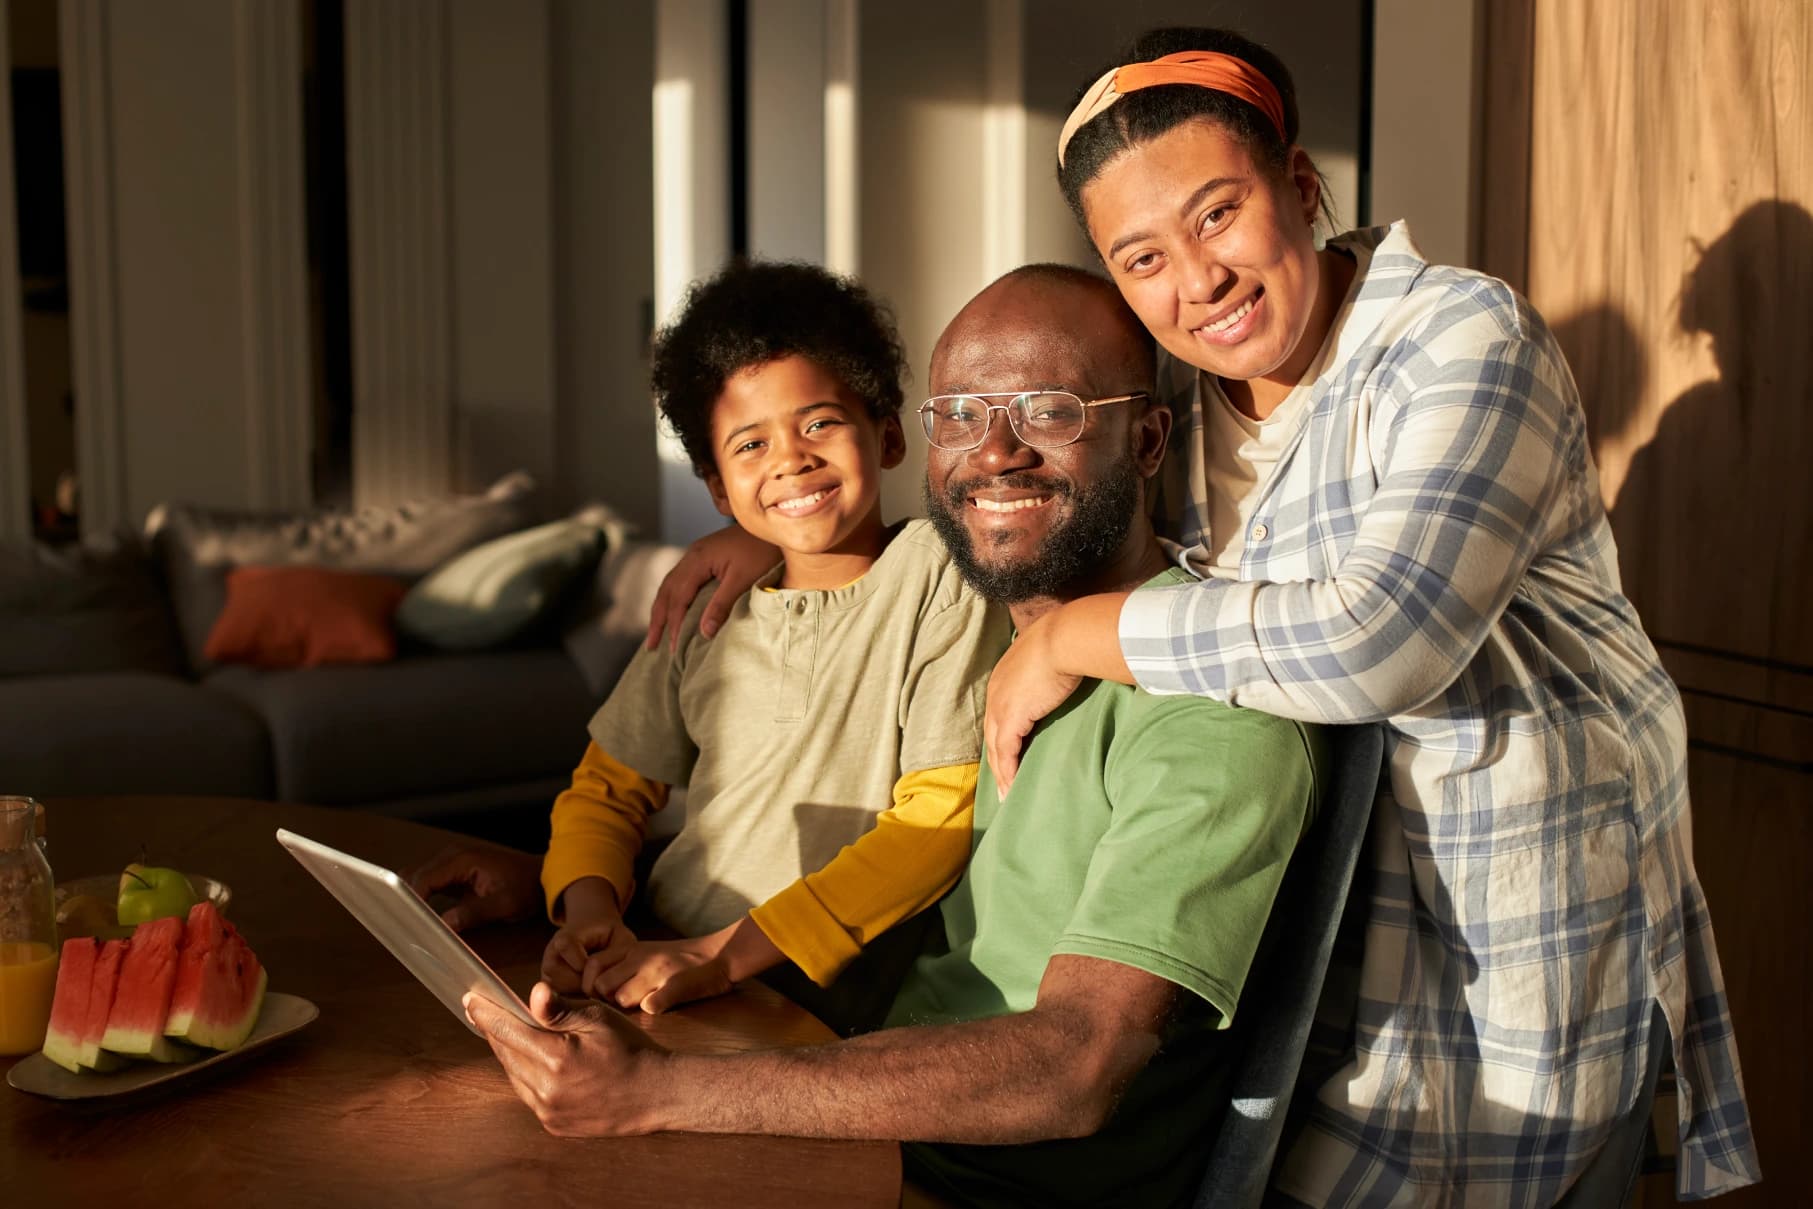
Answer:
xmin=1554 ymin=199 xmax=1813 ymax=667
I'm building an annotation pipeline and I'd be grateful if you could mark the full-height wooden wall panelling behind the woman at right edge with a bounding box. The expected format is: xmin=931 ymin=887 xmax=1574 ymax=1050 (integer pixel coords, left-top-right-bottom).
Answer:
xmin=1522 ymin=0 xmax=1813 ymax=1207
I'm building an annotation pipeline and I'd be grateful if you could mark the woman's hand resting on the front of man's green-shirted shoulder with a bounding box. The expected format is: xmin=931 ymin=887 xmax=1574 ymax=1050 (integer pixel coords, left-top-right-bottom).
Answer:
xmin=983 ymin=593 xmax=1133 ymax=798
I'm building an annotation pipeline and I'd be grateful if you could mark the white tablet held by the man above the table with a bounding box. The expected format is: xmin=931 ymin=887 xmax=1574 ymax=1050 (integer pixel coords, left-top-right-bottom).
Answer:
xmin=277 ymin=827 xmax=542 ymax=1033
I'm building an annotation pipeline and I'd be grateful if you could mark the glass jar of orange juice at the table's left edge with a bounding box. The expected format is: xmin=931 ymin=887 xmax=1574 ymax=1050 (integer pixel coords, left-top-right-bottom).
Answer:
xmin=0 ymin=796 xmax=56 ymax=1055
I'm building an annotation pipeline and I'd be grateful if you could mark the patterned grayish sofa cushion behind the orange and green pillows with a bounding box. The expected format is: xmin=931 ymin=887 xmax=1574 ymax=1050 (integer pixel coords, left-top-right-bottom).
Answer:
xmin=145 ymin=473 xmax=540 ymax=672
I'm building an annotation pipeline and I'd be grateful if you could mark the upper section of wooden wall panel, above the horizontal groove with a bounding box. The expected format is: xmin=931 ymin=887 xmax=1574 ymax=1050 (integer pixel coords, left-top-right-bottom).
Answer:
xmin=1528 ymin=0 xmax=1813 ymax=667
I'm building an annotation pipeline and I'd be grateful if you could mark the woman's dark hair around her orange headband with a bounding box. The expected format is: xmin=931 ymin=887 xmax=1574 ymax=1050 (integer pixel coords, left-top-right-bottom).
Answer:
xmin=1057 ymin=27 xmax=1334 ymax=230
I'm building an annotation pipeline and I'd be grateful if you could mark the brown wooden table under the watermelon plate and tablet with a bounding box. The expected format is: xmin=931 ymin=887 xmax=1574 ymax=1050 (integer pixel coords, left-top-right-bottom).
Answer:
xmin=0 ymin=798 xmax=899 ymax=1209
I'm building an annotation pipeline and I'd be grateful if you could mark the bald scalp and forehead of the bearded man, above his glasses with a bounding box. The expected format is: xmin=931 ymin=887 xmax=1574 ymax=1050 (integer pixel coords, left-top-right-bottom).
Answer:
xmin=932 ymin=265 xmax=1157 ymax=395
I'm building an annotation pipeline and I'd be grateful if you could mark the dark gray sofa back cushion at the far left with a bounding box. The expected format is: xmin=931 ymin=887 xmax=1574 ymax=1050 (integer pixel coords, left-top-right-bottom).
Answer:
xmin=0 ymin=535 xmax=183 ymax=678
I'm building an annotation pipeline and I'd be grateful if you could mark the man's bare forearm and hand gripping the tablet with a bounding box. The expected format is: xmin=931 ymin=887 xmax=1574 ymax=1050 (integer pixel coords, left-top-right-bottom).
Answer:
xmin=470 ymin=955 xmax=1178 ymax=1144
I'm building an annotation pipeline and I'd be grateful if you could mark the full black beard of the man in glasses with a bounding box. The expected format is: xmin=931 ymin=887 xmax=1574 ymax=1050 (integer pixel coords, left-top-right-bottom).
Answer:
xmin=925 ymin=453 xmax=1139 ymax=604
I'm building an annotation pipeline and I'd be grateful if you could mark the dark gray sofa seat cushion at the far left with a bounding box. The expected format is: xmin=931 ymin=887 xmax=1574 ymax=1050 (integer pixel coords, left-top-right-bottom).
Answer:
xmin=0 ymin=672 xmax=272 ymax=804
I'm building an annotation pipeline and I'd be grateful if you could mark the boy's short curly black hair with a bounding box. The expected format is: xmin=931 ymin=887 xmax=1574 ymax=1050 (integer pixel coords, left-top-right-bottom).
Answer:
xmin=651 ymin=261 xmax=907 ymax=477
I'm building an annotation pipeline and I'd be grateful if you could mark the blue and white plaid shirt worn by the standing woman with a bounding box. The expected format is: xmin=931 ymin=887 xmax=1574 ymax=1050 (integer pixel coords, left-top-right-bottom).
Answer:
xmin=1120 ymin=225 xmax=1759 ymax=1207
